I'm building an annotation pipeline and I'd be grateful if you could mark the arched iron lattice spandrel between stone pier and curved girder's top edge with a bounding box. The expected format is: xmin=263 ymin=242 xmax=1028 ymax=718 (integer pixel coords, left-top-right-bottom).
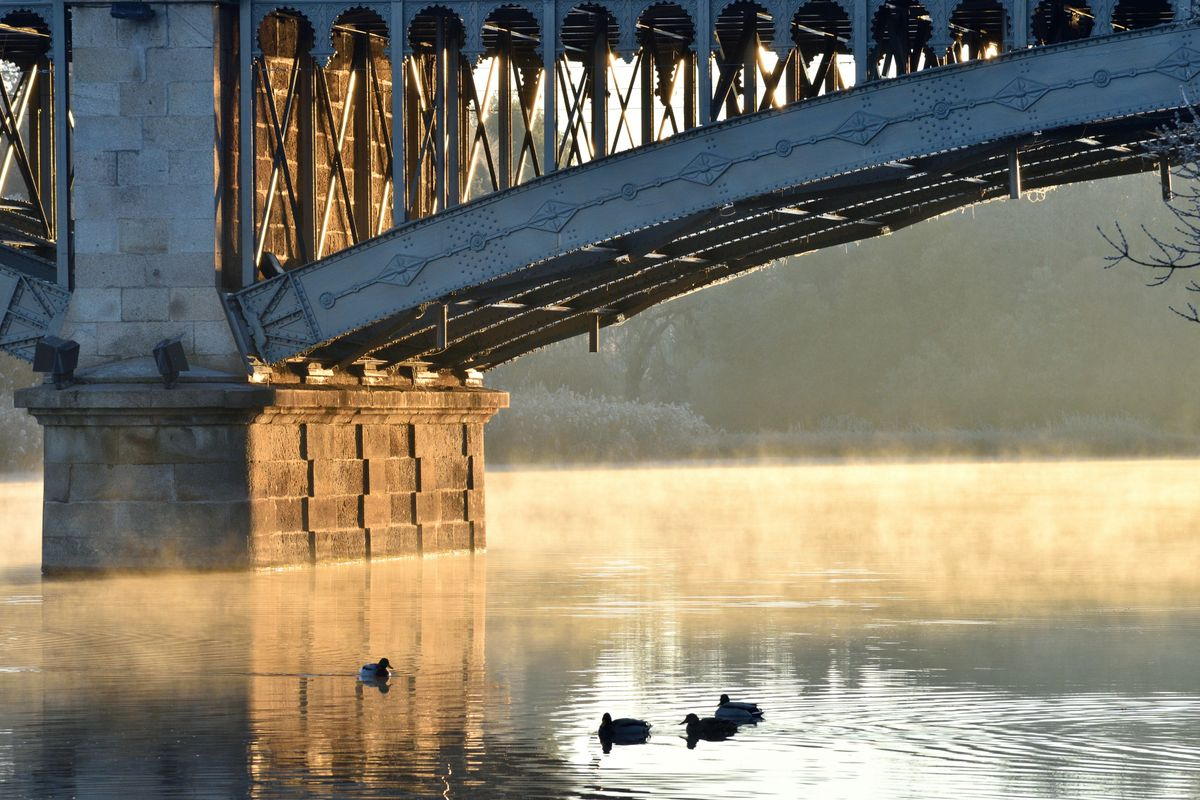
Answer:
xmin=240 ymin=0 xmax=1190 ymax=283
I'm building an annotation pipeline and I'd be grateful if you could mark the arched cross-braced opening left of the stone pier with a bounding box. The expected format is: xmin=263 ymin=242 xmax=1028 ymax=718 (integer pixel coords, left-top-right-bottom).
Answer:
xmin=0 ymin=11 xmax=58 ymax=260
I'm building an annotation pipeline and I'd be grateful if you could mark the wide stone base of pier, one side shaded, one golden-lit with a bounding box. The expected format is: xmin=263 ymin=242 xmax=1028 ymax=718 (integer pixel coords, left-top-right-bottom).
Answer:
xmin=17 ymin=374 xmax=508 ymax=571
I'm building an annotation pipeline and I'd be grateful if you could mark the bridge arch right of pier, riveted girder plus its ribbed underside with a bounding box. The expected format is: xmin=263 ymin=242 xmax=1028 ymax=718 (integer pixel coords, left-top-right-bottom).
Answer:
xmin=229 ymin=20 xmax=1200 ymax=371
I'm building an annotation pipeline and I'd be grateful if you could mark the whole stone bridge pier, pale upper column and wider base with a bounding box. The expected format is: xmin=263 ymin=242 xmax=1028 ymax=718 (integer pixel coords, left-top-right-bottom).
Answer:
xmin=17 ymin=1 xmax=508 ymax=571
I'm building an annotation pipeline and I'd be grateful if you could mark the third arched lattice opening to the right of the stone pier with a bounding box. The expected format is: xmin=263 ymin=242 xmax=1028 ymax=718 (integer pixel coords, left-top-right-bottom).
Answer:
xmin=404 ymin=6 xmax=470 ymax=217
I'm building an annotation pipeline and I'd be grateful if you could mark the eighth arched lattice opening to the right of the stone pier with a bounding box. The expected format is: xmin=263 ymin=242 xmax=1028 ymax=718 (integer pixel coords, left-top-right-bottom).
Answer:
xmin=787 ymin=0 xmax=854 ymax=102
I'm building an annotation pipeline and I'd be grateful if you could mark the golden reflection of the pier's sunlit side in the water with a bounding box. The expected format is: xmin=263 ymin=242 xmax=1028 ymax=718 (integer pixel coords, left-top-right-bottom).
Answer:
xmin=247 ymin=557 xmax=487 ymax=796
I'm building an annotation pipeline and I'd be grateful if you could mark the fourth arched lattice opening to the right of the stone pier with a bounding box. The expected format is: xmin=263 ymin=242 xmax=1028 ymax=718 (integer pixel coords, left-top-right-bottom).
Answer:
xmin=463 ymin=6 xmax=544 ymax=198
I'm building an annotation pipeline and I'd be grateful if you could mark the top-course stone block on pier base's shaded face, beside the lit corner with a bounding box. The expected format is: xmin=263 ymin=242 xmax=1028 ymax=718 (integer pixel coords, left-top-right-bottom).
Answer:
xmin=113 ymin=423 xmax=246 ymax=465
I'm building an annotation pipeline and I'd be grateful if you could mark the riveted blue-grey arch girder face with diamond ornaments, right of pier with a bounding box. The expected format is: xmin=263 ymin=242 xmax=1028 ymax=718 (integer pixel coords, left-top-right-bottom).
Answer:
xmin=227 ymin=24 xmax=1200 ymax=363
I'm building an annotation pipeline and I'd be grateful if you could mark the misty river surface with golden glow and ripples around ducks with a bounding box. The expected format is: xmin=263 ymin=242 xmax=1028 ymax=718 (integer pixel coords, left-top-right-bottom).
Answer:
xmin=0 ymin=461 xmax=1200 ymax=800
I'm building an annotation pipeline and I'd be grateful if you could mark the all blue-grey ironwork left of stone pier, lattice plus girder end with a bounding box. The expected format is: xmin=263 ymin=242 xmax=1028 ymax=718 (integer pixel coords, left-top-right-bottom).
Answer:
xmin=0 ymin=1 xmax=71 ymax=360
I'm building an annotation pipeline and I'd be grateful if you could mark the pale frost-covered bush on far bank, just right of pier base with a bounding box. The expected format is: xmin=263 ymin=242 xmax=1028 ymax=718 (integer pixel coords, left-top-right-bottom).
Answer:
xmin=487 ymin=386 xmax=715 ymax=463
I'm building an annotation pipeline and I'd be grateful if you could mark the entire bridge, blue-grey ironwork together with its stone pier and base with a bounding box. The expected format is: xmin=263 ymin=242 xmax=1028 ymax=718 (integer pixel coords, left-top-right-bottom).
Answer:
xmin=0 ymin=0 xmax=1200 ymax=569
